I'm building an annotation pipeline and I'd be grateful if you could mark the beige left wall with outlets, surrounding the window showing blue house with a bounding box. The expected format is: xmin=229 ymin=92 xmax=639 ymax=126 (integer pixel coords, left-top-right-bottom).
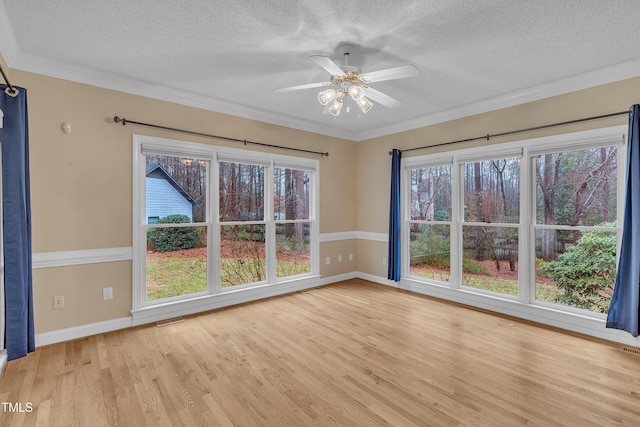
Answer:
xmin=9 ymin=70 xmax=356 ymax=333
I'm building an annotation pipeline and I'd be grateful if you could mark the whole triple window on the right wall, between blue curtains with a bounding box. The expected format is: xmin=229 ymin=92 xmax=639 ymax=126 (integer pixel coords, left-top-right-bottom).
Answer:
xmin=403 ymin=127 xmax=626 ymax=318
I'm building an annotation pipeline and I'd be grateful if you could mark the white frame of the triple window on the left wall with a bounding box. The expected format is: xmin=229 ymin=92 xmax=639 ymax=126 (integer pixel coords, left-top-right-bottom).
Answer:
xmin=132 ymin=135 xmax=320 ymax=324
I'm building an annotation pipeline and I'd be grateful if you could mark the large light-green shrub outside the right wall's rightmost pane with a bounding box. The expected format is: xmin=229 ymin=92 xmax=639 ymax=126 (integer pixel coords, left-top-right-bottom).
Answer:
xmin=540 ymin=224 xmax=616 ymax=313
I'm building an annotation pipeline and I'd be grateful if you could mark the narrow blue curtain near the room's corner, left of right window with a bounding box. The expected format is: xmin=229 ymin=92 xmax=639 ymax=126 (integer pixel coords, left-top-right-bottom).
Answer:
xmin=387 ymin=148 xmax=402 ymax=282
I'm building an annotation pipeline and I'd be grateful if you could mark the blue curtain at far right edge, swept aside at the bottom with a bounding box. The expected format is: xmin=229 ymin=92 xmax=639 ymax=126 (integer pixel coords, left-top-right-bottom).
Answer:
xmin=607 ymin=104 xmax=640 ymax=337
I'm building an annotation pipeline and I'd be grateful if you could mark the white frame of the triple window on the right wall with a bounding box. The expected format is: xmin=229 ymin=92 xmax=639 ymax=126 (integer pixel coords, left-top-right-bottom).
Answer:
xmin=401 ymin=126 xmax=628 ymax=339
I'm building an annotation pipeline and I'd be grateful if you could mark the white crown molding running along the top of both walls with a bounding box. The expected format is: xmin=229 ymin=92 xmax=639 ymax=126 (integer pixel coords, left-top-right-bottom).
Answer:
xmin=6 ymin=48 xmax=640 ymax=142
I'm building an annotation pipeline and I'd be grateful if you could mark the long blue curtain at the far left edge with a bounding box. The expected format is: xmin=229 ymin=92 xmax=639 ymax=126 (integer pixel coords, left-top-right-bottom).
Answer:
xmin=0 ymin=85 xmax=35 ymax=360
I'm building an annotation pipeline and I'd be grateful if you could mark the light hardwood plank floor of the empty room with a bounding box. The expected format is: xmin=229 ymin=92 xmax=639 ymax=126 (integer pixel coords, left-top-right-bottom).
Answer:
xmin=0 ymin=280 xmax=640 ymax=427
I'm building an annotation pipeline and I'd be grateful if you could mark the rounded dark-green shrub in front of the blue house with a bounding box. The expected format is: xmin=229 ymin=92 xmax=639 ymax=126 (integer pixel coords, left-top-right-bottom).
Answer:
xmin=147 ymin=214 xmax=200 ymax=252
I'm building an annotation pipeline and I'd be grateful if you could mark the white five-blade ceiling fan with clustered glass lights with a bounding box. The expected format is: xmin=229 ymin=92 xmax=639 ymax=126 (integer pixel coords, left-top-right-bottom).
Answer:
xmin=274 ymin=44 xmax=418 ymax=116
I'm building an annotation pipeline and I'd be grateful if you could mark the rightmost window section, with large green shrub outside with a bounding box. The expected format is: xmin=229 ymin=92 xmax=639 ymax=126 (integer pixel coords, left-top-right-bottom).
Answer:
xmin=532 ymin=145 xmax=622 ymax=313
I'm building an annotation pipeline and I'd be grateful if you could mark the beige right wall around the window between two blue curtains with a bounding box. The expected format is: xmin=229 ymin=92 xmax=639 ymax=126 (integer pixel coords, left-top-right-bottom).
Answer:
xmin=356 ymin=78 xmax=640 ymax=277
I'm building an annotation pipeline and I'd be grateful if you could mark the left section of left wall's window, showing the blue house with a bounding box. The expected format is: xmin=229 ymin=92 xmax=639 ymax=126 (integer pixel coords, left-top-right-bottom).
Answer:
xmin=144 ymin=154 xmax=211 ymax=301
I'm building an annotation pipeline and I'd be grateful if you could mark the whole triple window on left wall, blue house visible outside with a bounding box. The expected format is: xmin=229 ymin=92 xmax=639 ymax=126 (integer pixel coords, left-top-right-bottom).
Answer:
xmin=133 ymin=135 xmax=319 ymax=310
